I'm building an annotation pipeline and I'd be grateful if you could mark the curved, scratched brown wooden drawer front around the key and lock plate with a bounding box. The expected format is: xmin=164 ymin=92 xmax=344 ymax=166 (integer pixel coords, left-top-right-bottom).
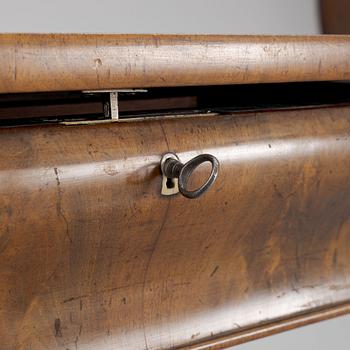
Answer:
xmin=0 ymin=107 xmax=350 ymax=350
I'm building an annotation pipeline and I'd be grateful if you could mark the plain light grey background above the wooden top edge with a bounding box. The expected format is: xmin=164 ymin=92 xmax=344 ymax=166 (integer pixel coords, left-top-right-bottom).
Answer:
xmin=0 ymin=0 xmax=320 ymax=34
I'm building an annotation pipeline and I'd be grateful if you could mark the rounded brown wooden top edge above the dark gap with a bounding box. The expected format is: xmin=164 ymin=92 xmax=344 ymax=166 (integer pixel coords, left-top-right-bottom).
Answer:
xmin=0 ymin=34 xmax=350 ymax=93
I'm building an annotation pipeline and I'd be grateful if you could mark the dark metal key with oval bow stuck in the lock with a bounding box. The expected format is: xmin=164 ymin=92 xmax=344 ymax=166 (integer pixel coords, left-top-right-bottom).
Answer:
xmin=161 ymin=153 xmax=219 ymax=199
